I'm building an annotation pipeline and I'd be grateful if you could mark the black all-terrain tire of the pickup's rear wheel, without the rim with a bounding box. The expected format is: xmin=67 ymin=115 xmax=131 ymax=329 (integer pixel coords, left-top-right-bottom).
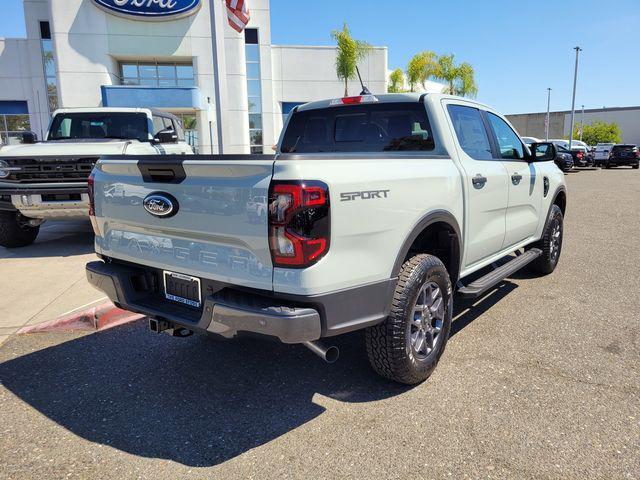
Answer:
xmin=365 ymin=254 xmax=453 ymax=385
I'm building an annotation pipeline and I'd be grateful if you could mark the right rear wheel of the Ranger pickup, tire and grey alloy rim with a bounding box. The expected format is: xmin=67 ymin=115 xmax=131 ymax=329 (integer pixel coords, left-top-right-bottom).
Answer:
xmin=365 ymin=254 xmax=453 ymax=385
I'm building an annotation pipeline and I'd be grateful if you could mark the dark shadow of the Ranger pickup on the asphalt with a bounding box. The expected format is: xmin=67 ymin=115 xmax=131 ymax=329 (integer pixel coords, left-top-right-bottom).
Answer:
xmin=0 ymin=283 xmax=516 ymax=467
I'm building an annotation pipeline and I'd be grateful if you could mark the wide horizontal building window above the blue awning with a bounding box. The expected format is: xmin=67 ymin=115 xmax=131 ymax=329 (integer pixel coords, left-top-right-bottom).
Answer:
xmin=120 ymin=62 xmax=195 ymax=87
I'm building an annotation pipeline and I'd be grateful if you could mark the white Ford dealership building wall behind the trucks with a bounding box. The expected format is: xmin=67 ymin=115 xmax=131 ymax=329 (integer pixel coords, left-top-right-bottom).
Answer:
xmin=0 ymin=0 xmax=387 ymax=153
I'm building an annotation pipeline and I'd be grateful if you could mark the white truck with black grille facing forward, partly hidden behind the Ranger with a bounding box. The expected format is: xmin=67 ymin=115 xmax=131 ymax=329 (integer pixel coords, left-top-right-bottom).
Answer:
xmin=0 ymin=108 xmax=193 ymax=248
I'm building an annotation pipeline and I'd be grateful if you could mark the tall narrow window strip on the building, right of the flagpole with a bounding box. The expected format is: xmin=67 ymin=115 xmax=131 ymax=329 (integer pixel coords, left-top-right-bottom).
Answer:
xmin=244 ymin=28 xmax=264 ymax=153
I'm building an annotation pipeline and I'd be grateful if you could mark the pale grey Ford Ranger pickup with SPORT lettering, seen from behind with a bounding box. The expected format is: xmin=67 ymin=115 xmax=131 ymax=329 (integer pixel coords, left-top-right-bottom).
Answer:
xmin=87 ymin=94 xmax=566 ymax=384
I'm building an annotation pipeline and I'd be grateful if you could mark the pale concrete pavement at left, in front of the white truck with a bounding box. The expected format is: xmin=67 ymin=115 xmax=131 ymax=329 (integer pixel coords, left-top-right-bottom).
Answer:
xmin=0 ymin=221 xmax=106 ymax=344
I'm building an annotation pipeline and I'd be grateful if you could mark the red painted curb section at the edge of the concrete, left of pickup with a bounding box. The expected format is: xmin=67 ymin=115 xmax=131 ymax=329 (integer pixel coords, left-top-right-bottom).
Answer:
xmin=18 ymin=302 xmax=144 ymax=333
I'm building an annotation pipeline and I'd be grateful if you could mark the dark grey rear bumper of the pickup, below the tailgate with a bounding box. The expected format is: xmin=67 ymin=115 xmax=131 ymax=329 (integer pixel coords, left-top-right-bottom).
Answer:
xmin=86 ymin=261 xmax=395 ymax=343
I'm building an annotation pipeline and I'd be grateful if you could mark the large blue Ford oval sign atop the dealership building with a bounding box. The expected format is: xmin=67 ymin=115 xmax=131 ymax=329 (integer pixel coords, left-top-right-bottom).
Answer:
xmin=93 ymin=0 xmax=202 ymax=20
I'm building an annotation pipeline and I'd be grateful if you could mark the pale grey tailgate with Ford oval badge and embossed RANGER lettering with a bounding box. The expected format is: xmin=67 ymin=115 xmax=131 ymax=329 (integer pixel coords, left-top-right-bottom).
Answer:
xmin=93 ymin=155 xmax=274 ymax=290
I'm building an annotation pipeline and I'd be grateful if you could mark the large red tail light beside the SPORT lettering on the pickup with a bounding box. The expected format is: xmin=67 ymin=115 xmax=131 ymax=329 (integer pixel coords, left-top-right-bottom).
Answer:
xmin=269 ymin=181 xmax=330 ymax=268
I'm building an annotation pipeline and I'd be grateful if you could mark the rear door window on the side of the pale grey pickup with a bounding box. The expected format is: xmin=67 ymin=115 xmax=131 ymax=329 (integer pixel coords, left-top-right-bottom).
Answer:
xmin=447 ymin=105 xmax=493 ymax=160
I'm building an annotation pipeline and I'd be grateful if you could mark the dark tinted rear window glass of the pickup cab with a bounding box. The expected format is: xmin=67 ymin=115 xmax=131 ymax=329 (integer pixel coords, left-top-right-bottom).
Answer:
xmin=282 ymin=102 xmax=435 ymax=153
